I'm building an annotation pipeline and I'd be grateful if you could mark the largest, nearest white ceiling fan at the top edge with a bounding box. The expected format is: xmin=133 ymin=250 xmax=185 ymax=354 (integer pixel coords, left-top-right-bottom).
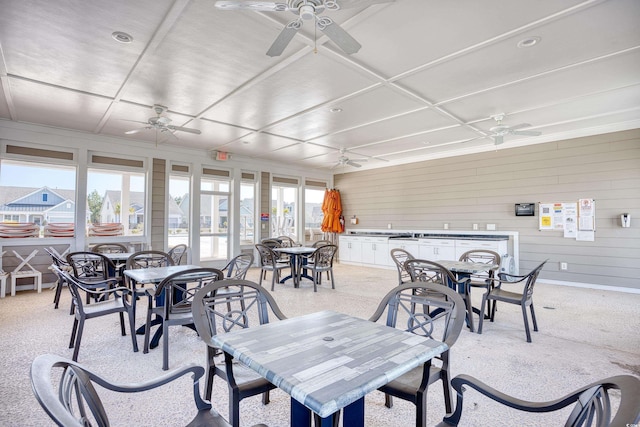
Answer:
xmin=216 ymin=0 xmax=395 ymax=57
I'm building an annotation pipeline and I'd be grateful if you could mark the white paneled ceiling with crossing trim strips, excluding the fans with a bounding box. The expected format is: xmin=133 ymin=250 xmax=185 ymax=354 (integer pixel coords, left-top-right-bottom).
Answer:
xmin=0 ymin=0 xmax=640 ymax=172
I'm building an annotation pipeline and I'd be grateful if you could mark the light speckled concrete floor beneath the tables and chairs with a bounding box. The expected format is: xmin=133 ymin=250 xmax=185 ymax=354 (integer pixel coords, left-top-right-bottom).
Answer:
xmin=0 ymin=265 xmax=640 ymax=427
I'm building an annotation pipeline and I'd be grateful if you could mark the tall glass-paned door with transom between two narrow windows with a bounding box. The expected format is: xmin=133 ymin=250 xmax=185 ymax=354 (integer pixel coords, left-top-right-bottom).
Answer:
xmin=200 ymin=169 xmax=230 ymax=261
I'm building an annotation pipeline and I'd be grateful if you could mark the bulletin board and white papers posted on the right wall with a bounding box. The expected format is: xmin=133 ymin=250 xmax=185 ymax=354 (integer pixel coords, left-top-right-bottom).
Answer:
xmin=538 ymin=199 xmax=596 ymax=242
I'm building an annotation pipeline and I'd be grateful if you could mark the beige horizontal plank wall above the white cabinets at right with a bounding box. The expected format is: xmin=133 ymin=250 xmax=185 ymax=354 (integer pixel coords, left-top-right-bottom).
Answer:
xmin=334 ymin=130 xmax=640 ymax=289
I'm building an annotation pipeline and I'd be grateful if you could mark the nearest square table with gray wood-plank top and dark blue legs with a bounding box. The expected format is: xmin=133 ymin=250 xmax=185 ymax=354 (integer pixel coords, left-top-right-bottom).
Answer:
xmin=213 ymin=311 xmax=447 ymax=427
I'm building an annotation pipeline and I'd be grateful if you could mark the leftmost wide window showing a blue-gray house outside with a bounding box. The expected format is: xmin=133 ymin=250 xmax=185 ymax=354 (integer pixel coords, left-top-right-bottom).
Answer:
xmin=0 ymin=160 xmax=76 ymax=237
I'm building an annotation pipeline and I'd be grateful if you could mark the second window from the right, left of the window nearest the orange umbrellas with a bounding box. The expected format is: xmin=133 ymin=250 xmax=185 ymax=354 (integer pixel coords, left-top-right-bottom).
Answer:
xmin=271 ymin=177 xmax=298 ymax=241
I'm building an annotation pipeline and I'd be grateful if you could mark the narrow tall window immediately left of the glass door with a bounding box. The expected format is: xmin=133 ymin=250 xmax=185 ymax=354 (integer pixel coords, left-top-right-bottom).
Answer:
xmin=167 ymin=174 xmax=191 ymax=248
